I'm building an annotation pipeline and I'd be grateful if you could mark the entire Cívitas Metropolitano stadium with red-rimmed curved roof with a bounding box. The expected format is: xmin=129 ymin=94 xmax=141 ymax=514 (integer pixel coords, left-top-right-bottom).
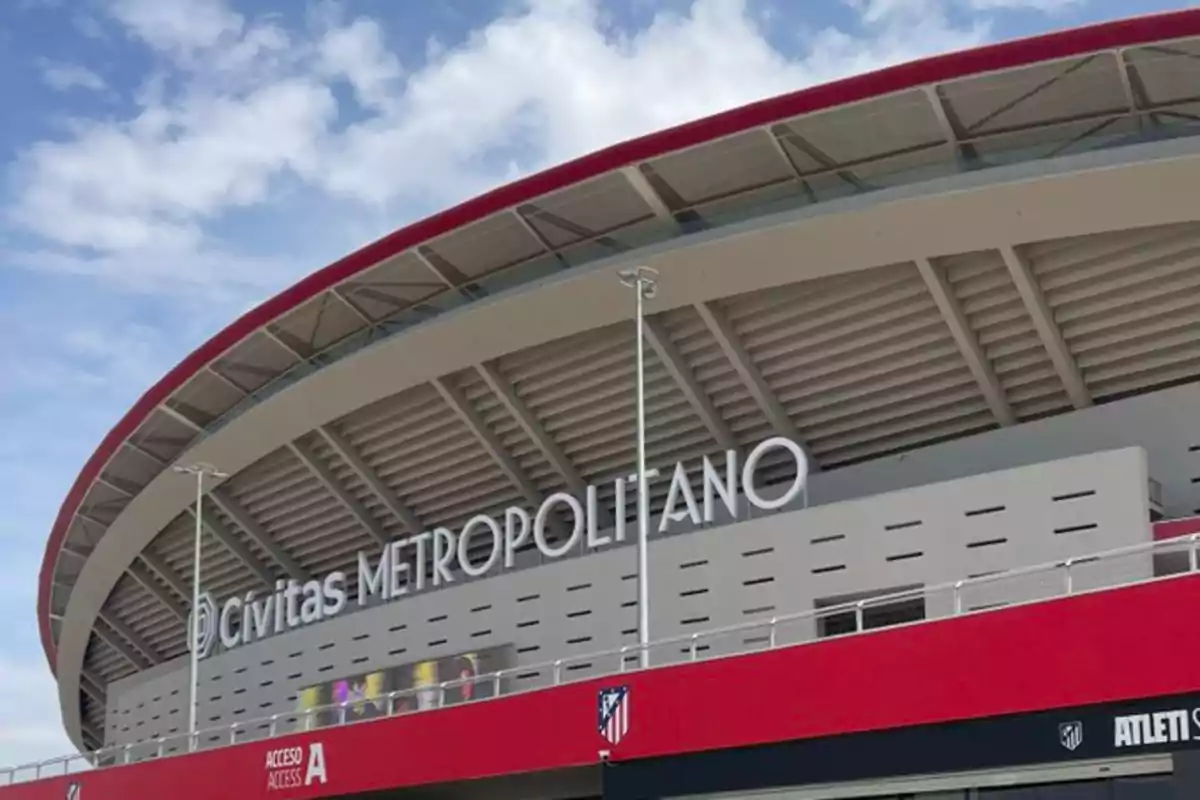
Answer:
xmin=11 ymin=10 xmax=1200 ymax=800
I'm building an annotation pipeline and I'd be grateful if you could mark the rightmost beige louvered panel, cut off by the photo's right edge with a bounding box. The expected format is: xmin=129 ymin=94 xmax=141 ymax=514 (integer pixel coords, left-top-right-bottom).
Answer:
xmin=1025 ymin=224 xmax=1200 ymax=401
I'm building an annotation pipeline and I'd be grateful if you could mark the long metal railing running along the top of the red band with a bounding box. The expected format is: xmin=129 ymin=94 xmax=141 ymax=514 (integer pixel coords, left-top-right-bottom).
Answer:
xmin=9 ymin=534 xmax=1200 ymax=787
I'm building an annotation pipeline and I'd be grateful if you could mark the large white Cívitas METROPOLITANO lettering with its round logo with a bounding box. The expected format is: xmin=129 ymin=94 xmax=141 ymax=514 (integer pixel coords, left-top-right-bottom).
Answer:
xmin=190 ymin=437 xmax=809 ymax=657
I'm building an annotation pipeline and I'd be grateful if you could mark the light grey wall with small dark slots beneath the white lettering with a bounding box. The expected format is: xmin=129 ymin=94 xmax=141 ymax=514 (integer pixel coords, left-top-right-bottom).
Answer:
xmin=106 ymin=443 xmax=1151 ymax=758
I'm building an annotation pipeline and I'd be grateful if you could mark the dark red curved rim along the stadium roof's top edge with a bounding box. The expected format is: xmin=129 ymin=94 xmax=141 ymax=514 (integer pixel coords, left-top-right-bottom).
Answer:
xmin=37 ymin=8 xmax=1200 ymax=672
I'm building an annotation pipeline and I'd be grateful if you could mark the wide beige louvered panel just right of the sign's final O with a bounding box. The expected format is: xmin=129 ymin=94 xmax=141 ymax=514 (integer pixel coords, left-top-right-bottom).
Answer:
xmin=710 ymin=264 xmax=983 ymax=461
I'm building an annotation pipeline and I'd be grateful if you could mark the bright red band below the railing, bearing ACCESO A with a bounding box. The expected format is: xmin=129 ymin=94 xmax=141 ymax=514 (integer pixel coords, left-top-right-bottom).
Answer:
xmin=9 ymin=576 xmax=1200 ymax=800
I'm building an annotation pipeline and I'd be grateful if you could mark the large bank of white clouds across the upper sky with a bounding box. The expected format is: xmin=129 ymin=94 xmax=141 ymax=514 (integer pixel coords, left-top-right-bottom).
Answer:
xmin=8 ymin=0 xmax=1069 ymax=297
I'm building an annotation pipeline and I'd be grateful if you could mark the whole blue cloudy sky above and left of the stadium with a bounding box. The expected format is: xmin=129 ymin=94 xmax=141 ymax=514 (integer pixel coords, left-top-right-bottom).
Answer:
xmin=0 ymin=0 xmax=1189 ymax=766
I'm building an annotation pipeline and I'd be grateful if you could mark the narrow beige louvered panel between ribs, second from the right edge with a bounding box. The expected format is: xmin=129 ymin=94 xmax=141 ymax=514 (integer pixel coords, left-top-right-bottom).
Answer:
xmin=938 ymin=251 xmax=1070 ymax=420
